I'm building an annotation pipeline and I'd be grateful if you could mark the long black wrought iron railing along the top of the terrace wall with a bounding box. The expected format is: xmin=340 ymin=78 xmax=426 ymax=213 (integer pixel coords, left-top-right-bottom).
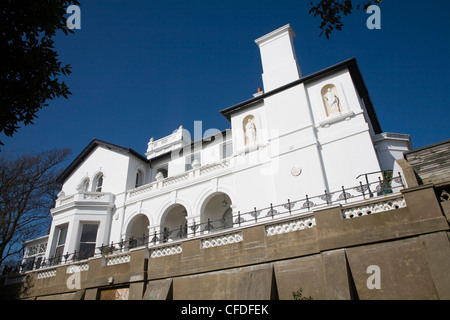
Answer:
xmin=4 ymin=171 xmax=405 ymax=273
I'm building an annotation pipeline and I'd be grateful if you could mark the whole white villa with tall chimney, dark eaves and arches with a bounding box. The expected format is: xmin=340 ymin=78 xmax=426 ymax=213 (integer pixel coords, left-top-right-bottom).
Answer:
xmin=34 ymin=25 xmax=411 ymax=262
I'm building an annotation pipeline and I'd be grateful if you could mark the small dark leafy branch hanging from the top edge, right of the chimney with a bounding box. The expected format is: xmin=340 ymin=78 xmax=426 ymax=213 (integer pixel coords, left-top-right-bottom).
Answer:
xmin=309 ymin=0 xmax=382 ymax=39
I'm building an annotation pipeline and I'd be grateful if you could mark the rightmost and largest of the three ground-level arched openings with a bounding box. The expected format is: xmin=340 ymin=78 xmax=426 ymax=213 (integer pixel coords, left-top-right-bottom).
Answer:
xmin=200 ymin=192 xmax=233 ymax=232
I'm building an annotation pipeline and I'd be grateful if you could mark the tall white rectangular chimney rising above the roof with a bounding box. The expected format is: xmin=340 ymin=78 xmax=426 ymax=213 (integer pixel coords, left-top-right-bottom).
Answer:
xmin=255 ymin=24 xmax=301 ymax=92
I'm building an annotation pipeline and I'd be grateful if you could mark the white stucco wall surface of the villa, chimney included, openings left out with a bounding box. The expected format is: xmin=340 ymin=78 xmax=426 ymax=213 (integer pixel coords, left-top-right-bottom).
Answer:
xmin=41 ymin=26 xmax=409 ymax=264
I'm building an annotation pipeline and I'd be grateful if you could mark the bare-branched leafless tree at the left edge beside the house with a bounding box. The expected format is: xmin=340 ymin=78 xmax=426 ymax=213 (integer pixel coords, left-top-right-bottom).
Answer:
xmin=0 ymin=149 xmax=70 ymax=265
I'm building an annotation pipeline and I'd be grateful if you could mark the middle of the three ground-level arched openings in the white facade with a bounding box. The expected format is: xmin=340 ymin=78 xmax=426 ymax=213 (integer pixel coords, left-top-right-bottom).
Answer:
xmin=160 ymin=204 xmax=187 ymax=242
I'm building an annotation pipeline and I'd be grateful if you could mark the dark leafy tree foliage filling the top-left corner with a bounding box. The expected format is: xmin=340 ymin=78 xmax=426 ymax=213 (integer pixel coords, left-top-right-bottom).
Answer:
xmin=0 ymin=0 xmax=79 ymax=145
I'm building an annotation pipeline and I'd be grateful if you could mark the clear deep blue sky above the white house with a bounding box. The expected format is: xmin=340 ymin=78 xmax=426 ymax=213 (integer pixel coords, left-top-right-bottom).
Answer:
xmin=1 ymin=0 xmax=450 ymax=160
